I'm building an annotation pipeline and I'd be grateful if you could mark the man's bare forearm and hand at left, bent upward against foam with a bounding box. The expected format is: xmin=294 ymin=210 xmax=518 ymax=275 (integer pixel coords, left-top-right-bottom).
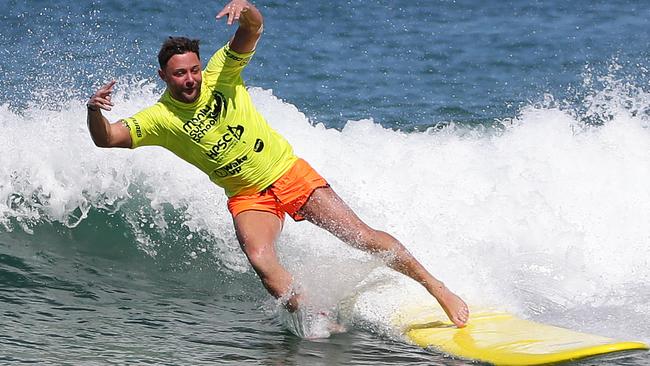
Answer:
xmin=86 ymin=81 xmax=132 ymax=148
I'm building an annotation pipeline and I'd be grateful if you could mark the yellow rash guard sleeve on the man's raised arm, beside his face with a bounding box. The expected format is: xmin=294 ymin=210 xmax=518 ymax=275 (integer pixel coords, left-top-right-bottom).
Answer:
xmin=203 ymin=44 xmax=255 ymax=86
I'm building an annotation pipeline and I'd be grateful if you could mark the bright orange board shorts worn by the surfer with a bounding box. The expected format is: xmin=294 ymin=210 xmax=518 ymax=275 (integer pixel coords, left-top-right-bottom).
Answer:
xmin=228 ymin=159 xmax=329 ymax=221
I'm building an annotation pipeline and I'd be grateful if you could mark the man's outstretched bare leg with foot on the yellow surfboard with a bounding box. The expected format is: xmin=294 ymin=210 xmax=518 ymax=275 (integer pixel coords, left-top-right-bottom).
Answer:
xmin=298 ymin=187 xmax=469 ymax=327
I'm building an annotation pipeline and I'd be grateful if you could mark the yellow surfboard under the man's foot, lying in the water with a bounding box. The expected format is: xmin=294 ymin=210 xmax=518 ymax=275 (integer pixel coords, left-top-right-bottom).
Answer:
xmin=395 ymin=306 xmax=648 ymax=365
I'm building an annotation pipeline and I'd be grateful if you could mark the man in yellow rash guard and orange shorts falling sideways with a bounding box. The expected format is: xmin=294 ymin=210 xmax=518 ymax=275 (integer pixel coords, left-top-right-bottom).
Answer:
xmin=87 ymin=0 xmax=469 ymax=327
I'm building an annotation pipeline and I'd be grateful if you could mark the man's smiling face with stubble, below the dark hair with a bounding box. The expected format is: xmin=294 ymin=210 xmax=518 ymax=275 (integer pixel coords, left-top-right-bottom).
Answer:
xmin=158 ymin=52 xmax=202 ymax=103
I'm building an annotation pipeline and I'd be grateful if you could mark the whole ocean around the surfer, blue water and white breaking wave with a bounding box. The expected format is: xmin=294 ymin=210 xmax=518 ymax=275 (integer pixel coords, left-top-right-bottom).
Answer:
xmin=0 ymin=0 xmax=650 ymax=365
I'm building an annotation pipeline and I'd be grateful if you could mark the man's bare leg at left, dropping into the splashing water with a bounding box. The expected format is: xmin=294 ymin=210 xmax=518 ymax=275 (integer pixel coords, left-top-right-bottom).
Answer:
xmin=234 ymin=211 xmax=298 ymax=311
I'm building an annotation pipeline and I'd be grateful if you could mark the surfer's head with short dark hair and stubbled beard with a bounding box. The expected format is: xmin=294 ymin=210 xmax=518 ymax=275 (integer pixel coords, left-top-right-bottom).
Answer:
xmin=158 ymin=37 xmax=202 ymax=103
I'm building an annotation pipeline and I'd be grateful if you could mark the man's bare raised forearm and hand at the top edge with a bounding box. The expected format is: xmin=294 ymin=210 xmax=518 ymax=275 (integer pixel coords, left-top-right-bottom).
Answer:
xmin=217 ymin=0 xmax=264 ymax=54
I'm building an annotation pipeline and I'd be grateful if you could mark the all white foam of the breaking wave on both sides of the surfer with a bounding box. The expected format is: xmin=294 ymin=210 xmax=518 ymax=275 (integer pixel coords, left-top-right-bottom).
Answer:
xmin=0 ymin=78 xmax=650 ymax=339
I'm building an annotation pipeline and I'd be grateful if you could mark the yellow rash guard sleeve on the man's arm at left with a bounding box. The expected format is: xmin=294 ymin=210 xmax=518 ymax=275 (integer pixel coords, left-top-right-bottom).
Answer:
xmin=122 ymin=105 xmax=167 ymax=149
